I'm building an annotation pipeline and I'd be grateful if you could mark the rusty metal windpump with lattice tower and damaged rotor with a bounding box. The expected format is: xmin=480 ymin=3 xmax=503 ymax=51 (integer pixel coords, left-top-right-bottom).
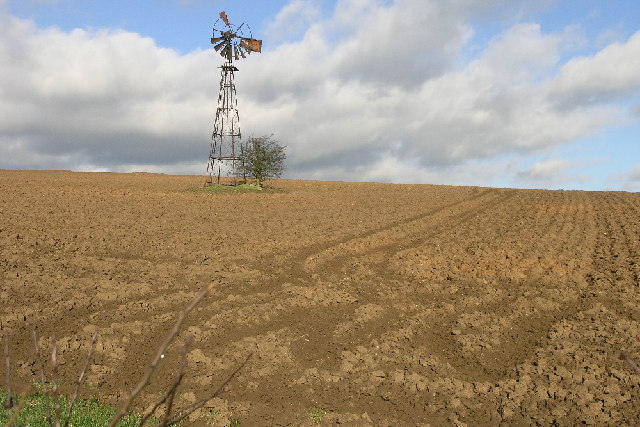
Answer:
xmin=207 ymin=12 xmax=262 ymax=184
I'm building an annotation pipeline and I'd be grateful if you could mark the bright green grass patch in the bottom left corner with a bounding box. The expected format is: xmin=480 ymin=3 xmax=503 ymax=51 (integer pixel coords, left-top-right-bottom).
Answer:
xmin=0 ymin=393 xmax=143 ymax=427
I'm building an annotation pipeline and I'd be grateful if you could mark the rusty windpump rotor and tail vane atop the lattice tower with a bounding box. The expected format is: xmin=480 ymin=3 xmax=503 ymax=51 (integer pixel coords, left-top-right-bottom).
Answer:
xmin=211 ymin=12 xmax=262 ymax=62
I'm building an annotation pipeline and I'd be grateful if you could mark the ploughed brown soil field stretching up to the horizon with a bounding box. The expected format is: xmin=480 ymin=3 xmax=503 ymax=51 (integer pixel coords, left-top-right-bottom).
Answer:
xmin=0 ymin=171 xmax=640 ymax=425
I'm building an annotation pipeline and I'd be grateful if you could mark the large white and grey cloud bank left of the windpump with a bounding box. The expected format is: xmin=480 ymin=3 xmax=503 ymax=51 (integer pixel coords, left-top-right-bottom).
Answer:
xmin=0 ymin=16 xmax=216 ymax=168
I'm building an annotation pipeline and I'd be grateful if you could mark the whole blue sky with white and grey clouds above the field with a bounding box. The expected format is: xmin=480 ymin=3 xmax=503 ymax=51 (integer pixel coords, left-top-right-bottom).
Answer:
xmin=0 ymin=0 xmax=640 ymax=192
